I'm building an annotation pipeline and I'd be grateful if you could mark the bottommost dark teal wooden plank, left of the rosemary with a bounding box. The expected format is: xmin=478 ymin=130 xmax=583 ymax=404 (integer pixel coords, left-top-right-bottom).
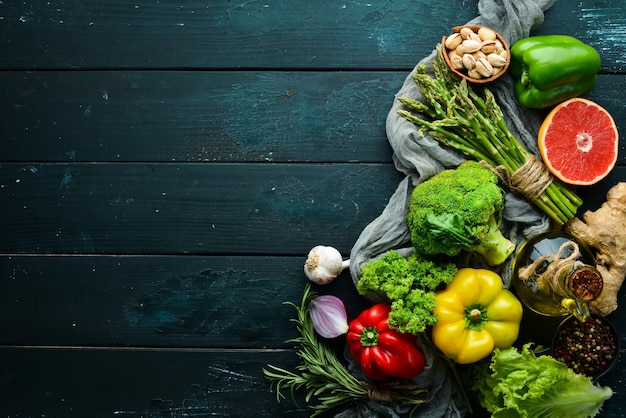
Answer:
xmin=0 ymin=347 xmax=309 ymax=418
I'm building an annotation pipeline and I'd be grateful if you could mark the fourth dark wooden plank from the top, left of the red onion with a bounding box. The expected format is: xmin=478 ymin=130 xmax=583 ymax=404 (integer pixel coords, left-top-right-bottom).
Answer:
xmin=0 ymin=255 xmax=368 ymax=348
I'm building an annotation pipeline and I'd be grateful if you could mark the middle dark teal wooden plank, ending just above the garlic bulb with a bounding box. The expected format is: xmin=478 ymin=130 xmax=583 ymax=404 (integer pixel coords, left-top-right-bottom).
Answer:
xmin=0 ymin=163 xmax=401 ymax=255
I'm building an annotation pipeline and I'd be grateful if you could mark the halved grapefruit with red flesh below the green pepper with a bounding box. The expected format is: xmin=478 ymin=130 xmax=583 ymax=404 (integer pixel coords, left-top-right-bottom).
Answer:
xmin=538 ymin=97 xmax=619 ymax=185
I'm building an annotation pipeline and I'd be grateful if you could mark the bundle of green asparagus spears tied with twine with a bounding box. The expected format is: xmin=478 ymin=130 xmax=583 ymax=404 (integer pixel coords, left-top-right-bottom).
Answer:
xmin=398 ymin=48 xmax=582 ymax=226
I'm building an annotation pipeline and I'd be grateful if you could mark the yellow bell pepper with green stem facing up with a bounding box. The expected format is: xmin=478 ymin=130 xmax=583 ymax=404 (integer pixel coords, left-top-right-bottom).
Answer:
xmin=432 ymin=268 xmax=522 ymax=364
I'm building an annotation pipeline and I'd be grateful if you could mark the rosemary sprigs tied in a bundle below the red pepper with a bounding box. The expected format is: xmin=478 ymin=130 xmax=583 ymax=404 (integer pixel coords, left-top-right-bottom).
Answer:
xmin=263 ymin=284 xmax=428 ymax=417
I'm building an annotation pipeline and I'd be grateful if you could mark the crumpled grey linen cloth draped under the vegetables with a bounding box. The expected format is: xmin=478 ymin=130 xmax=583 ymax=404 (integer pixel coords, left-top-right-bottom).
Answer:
xmin=344 ymin=0 xmax=556 ymax=418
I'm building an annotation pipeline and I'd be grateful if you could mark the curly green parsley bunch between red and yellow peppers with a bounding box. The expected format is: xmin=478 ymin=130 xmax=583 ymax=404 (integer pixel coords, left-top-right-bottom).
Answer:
xmin=357 ymin=250 xmax=458 ymax=334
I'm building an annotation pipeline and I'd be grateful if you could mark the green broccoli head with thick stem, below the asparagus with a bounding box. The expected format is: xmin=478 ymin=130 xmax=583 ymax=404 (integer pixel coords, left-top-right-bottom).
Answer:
xmin=407 ymin=161 xmax=515 ymax=266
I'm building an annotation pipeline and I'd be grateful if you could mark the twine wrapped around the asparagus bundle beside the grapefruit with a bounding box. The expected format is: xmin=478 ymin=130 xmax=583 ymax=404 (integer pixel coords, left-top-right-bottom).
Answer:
xmin=481 ymin=154 xmax=554 ymax=202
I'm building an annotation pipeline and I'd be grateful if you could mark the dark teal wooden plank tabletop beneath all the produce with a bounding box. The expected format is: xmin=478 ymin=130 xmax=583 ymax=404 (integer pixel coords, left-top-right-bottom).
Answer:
xmin=0 ymin=0 xmax=626 ymax=418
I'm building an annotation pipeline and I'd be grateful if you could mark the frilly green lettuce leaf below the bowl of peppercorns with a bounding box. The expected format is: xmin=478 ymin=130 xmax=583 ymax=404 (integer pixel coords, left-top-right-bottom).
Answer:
xmin=472 ymin=344 xmax=613 ymax=418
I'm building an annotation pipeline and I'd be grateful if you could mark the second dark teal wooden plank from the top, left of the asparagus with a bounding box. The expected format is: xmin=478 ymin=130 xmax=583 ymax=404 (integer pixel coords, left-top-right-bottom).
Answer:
xmin=0 ymin=71 xmax=406 ymax=162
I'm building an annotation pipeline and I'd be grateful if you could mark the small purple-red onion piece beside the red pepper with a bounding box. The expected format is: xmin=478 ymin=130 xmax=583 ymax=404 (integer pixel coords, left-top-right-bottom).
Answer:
xmin=309 ymin=295 xmax=348 ymax=338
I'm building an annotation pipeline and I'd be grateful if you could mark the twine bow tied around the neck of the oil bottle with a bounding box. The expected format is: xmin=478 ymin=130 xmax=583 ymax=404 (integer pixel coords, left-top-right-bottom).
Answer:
xmin=518 ymin=241 xmax=580 ymax=296
